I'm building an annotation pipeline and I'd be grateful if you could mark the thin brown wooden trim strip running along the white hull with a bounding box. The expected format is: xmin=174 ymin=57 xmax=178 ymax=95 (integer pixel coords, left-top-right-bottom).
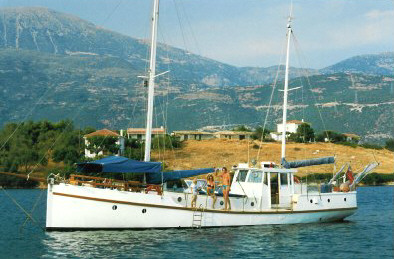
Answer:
xmin=53 ymin=192 xmax=357 ymax=214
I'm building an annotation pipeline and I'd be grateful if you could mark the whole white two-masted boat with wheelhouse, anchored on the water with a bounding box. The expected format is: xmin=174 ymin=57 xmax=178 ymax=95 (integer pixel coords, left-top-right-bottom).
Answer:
xmin=46 ymin=0 xmax=373 ymax=230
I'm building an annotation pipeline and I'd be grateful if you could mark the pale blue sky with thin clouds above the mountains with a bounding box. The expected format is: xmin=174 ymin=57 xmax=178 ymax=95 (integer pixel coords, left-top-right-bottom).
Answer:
xmin=0 ymin=0 xmax=394 ymax=68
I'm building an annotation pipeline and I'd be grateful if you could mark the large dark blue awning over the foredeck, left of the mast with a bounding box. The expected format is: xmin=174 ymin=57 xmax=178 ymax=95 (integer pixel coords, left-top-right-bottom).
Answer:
xmin=77 ymin=156 xmax=161 ymax=173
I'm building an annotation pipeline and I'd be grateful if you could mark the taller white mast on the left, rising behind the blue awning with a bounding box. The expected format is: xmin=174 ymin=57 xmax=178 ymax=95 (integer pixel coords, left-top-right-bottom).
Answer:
xmin=144 ymin=0 xmax=159 ymax=162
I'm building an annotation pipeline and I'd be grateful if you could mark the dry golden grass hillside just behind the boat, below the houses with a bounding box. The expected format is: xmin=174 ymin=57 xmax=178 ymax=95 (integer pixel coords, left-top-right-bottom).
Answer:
xmin=153 ymin=139 xmax=394 ymax=175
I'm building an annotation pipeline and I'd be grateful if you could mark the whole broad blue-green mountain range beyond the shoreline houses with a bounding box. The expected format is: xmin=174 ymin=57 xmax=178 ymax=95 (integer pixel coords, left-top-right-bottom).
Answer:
xmin=0 ymin=8 xmax=394 ymax=143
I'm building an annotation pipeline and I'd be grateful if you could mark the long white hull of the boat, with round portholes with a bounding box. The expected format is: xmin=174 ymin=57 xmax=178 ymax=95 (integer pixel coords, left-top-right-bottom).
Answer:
xmin=46 ymin=184 xmax=357 ymax=230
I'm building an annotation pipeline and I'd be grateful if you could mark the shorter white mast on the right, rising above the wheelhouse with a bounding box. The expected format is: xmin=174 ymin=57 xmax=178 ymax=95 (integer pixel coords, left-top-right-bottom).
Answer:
xmin=281 ymin=11 xmax=292 ymax=161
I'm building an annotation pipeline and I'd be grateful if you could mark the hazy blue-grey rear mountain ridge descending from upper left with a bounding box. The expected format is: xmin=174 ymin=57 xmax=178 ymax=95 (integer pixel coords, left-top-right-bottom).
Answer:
xmin=0 ymin=7 xmax=302 ymax=88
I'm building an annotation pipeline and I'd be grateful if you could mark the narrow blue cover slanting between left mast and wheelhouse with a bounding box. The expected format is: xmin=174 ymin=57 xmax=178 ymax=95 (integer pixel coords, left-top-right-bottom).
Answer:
xmin=146 ymin=168 xmax=215 ymax=184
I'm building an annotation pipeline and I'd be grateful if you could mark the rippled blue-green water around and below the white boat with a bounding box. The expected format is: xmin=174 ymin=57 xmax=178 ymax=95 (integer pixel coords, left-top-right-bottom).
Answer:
xmin=0 ymin=187 xmax=394 ymax=259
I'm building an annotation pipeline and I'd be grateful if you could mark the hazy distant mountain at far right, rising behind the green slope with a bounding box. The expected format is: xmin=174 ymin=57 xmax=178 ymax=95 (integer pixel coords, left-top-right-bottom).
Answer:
xmin=320 ymin=52 xmax=394 ymax=76
